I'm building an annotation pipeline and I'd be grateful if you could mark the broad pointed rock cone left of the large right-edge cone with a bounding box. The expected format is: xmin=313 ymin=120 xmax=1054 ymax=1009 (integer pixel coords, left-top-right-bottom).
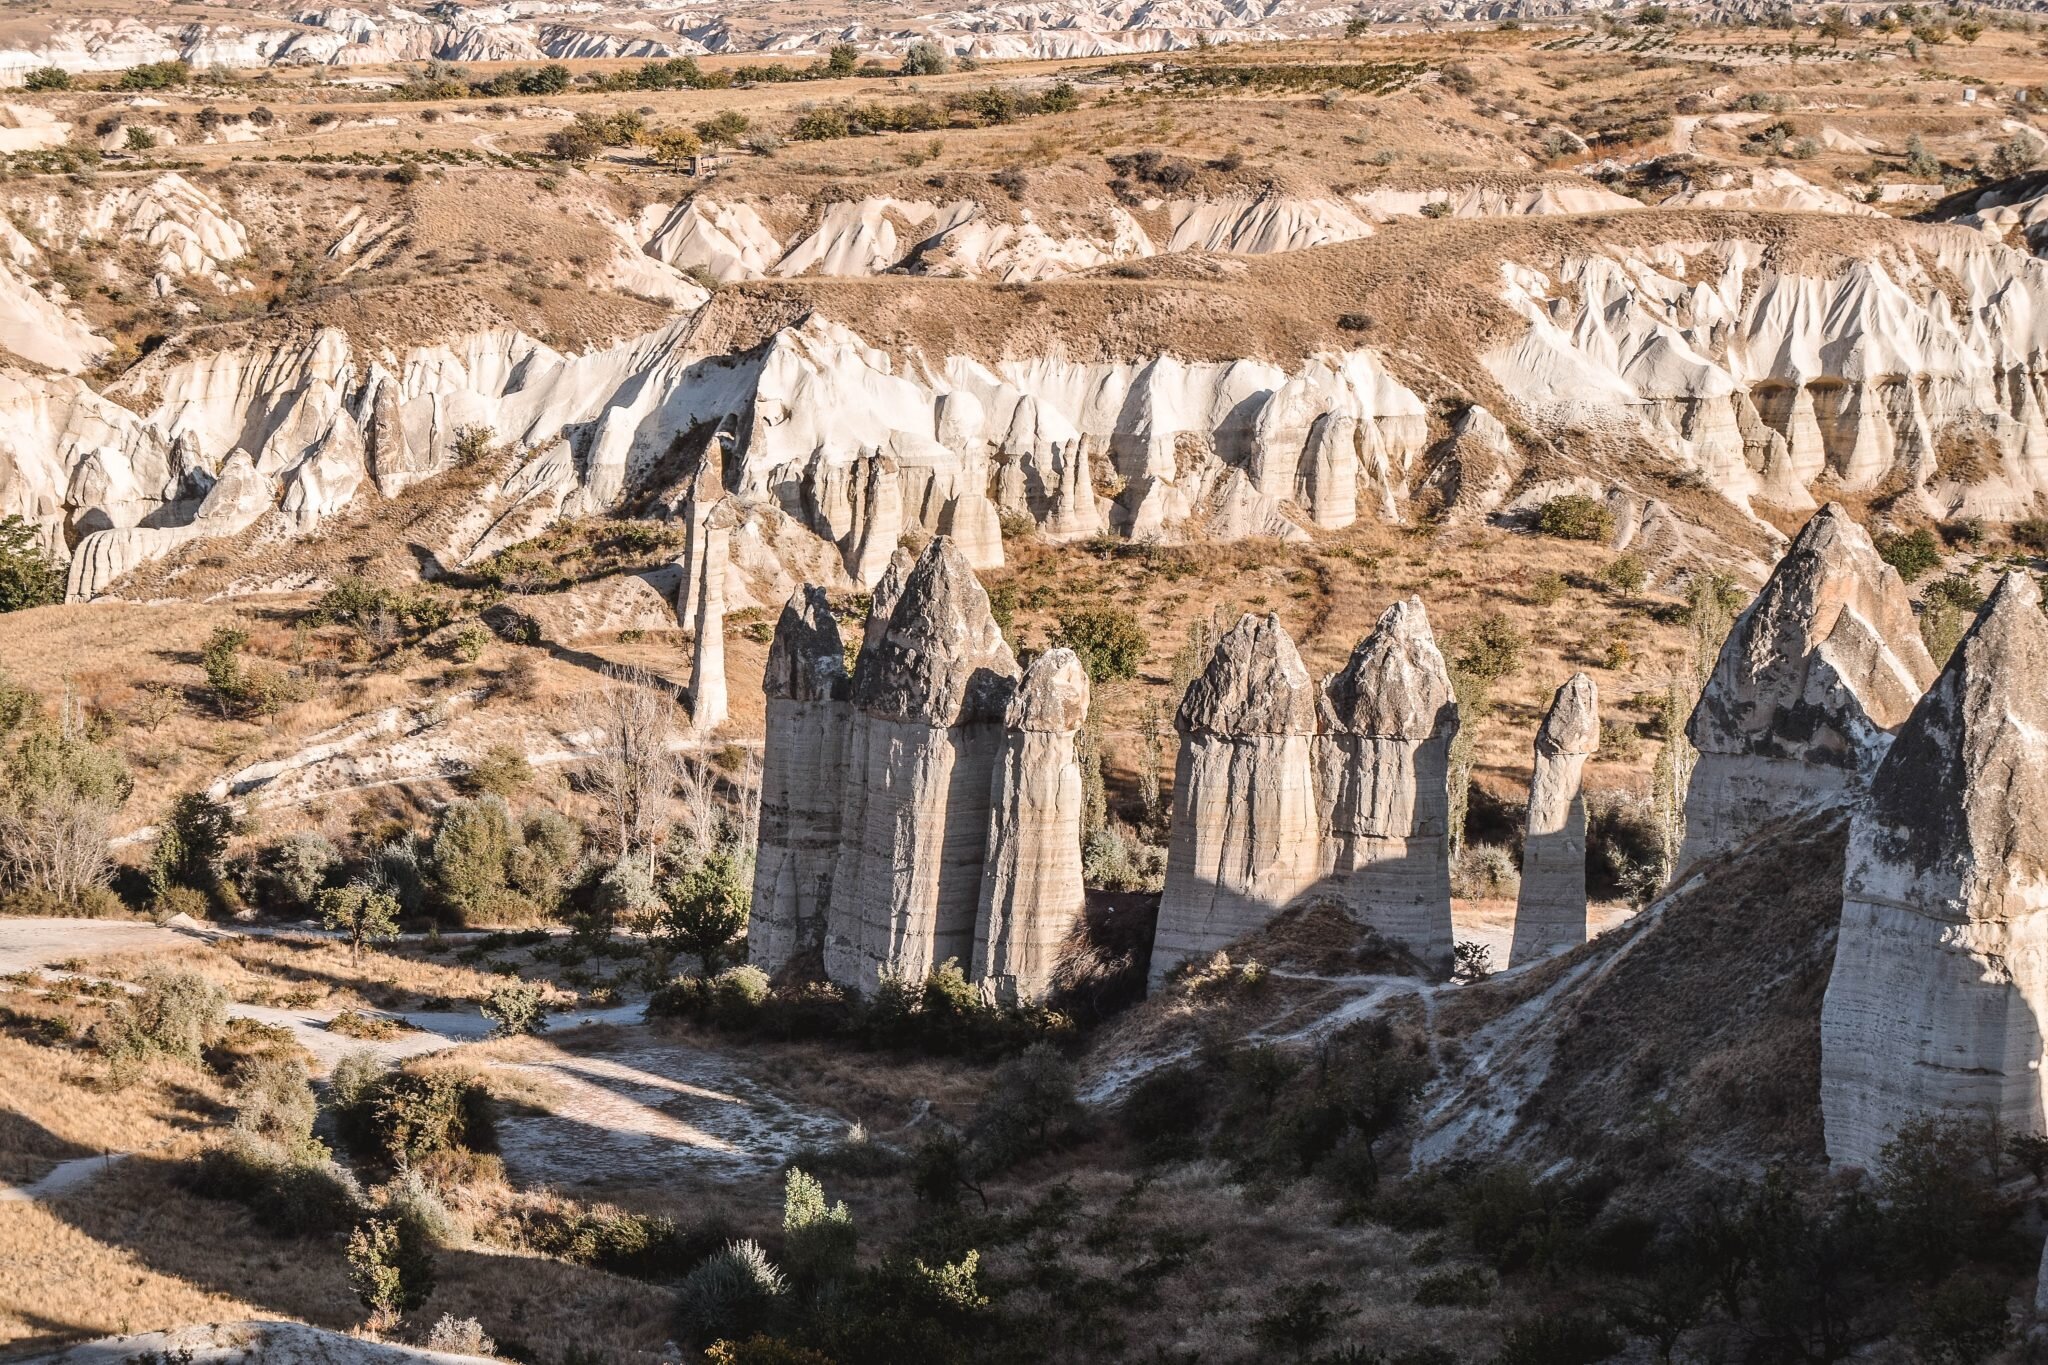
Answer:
xmin=1679 ymin=503 xmax=1935 ymax=870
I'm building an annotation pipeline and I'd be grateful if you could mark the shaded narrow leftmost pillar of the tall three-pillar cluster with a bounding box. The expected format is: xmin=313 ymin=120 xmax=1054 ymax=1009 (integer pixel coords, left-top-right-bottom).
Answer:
xmin=748 ymin=587 xmax=852 ymax=974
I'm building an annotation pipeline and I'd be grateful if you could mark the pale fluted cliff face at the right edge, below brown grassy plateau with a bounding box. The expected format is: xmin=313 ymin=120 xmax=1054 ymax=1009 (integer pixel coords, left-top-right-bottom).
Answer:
xmin=1485 ymin=231 xmax=2048 ymax=520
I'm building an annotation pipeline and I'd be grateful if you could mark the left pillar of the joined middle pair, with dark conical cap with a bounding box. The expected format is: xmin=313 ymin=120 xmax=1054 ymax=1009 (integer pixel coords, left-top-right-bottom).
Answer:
xmin=1151 ymin=616 xmax=1319 ymax=984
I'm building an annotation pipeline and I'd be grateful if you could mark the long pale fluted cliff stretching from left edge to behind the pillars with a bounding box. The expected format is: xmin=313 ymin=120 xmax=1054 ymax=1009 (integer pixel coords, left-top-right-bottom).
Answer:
xmin=32 ymin=317 xmax=1427 ymax=596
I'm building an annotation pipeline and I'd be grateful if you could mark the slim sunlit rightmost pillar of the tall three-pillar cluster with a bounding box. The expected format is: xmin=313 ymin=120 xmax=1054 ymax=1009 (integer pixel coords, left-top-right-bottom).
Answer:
xmin=971 ymin=649 xmax=1087 ymax=1003
